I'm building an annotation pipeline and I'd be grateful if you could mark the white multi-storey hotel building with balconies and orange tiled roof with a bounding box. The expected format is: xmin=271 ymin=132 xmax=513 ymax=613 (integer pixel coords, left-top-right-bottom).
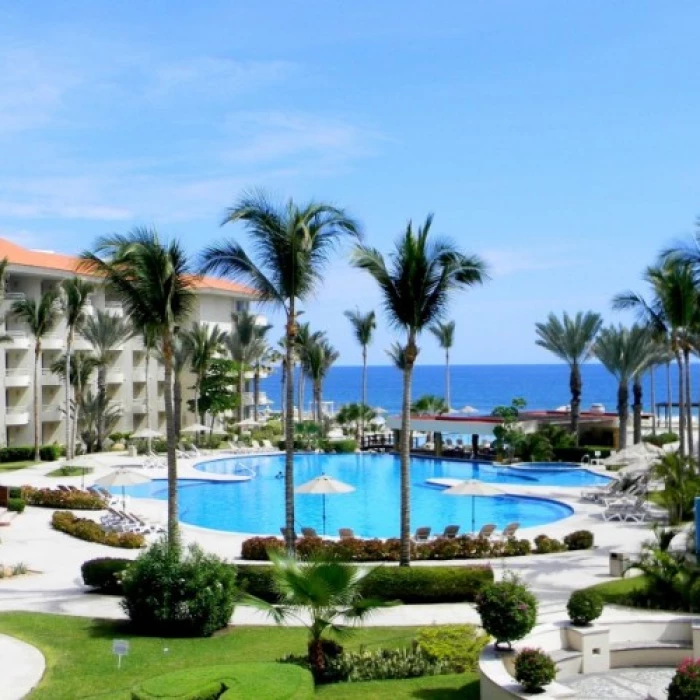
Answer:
xmin=0 ymin=238 xmax=267 ymax=445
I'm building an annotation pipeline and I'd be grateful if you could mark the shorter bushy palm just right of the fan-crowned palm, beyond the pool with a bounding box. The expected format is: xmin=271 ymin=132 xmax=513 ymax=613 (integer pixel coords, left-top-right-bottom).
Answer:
xmin=593 ymin=326 xmax=651 ymax=449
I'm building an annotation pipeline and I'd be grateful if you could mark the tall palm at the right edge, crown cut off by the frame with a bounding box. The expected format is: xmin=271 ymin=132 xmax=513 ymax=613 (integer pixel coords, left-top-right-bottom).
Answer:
xmin=613 ymin=257 xmax=699 ymax=455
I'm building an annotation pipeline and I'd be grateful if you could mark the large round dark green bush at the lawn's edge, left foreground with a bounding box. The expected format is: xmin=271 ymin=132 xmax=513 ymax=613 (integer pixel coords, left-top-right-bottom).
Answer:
xmin=122 ymin=540 xmax=236 ymax=637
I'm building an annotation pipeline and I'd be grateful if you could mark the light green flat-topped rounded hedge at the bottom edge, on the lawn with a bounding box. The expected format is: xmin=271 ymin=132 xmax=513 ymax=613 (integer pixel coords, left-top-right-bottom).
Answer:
xmin=131 ymin=663 xmax=314 ymax=700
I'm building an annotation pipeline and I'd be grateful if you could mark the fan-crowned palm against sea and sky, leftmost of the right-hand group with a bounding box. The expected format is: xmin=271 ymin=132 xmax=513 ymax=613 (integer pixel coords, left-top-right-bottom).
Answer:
xmin=535 ymin=311 xmax=603 ymax=443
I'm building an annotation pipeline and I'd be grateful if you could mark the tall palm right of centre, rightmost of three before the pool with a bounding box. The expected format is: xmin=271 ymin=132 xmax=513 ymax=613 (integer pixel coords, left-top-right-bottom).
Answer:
xmin=353 ymin=215 xmax=486 ymax=566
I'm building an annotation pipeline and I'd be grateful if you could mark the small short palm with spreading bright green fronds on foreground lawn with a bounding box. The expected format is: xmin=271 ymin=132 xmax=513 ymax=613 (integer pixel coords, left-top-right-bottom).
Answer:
xmin=243 ymin=551 xmax=394 ymax=675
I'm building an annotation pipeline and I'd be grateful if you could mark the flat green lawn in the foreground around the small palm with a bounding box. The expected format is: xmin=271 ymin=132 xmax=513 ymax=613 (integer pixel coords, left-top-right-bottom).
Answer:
xmin=0 ymin=613 xmax=479 ymax=700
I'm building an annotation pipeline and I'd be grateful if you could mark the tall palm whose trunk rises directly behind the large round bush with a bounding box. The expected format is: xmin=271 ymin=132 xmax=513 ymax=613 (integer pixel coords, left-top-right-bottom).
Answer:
xmin=82 ymin=228 xmax=194 ymax=551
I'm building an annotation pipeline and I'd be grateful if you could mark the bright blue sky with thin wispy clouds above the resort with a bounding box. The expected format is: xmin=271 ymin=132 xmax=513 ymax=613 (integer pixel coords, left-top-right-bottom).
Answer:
xmin=0 ymin=5 xmax=700 ymax=364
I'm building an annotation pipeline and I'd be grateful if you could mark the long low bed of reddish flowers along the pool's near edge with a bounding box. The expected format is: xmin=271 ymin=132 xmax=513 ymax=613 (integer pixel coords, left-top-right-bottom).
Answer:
xmin=241 ymin=533 xmax=593 ymax=562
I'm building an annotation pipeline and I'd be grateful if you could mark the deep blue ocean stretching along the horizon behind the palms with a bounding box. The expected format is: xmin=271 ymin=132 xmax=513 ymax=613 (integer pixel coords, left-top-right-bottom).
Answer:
xmin=261 ymin=363 xmax=700 ymax=414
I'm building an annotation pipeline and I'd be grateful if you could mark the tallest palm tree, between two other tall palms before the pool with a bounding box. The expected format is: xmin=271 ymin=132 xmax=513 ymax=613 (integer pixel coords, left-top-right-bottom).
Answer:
xmin=202 ymin=192 xmax=360 ymax=551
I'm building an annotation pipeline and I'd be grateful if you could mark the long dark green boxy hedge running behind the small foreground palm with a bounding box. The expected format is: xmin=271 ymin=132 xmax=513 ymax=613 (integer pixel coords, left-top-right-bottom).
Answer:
xmin=236 ymin=564 xmax=493 ymax=605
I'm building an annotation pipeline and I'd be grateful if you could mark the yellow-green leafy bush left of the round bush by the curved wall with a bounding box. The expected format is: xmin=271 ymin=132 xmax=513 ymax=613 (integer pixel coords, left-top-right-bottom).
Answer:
xmin=416 ymin=625 xmax=489 ymax=673
